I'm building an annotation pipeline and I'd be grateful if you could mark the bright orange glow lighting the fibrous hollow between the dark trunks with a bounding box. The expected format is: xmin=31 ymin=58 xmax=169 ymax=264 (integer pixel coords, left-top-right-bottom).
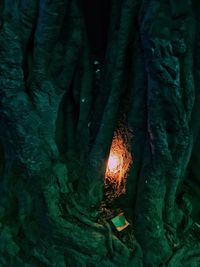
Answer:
xmin=105 ymin=133 xmax=132 ymax=197
